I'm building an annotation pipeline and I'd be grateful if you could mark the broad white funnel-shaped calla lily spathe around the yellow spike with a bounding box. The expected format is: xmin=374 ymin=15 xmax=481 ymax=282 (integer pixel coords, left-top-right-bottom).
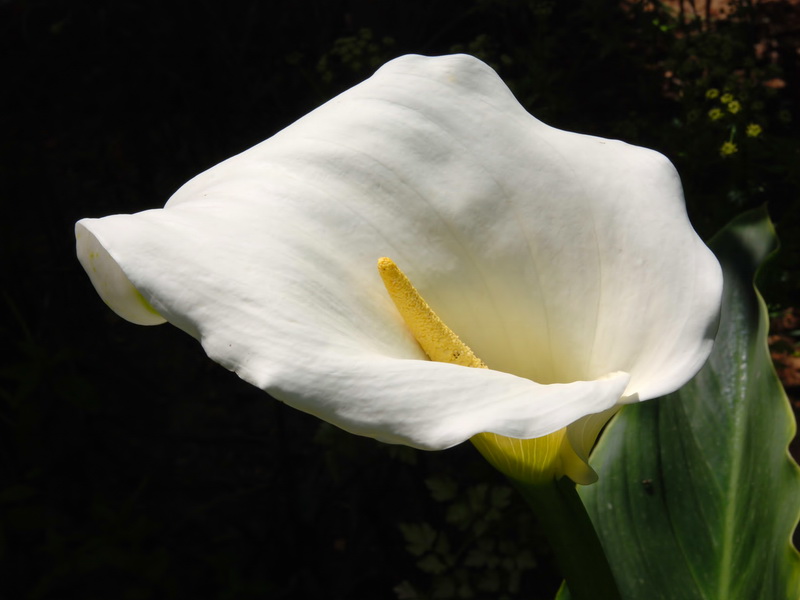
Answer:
xmin=76 ymin=55 xmax=722 ymax=483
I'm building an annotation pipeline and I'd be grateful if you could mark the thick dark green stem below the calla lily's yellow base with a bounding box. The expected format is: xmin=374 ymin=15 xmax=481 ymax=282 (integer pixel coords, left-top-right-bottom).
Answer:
xmin=511 ymin=477 xmax=621 ymax=600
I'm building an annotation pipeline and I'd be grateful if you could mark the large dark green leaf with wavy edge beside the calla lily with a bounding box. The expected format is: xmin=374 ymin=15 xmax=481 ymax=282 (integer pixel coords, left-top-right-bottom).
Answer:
xmin=559 ymin=210 xmax=800 ymax=600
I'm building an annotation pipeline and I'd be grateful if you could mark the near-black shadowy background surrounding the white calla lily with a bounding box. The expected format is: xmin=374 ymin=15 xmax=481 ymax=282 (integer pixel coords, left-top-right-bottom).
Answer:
xmin=0 ymin=0 xmax=800 ymax=600
